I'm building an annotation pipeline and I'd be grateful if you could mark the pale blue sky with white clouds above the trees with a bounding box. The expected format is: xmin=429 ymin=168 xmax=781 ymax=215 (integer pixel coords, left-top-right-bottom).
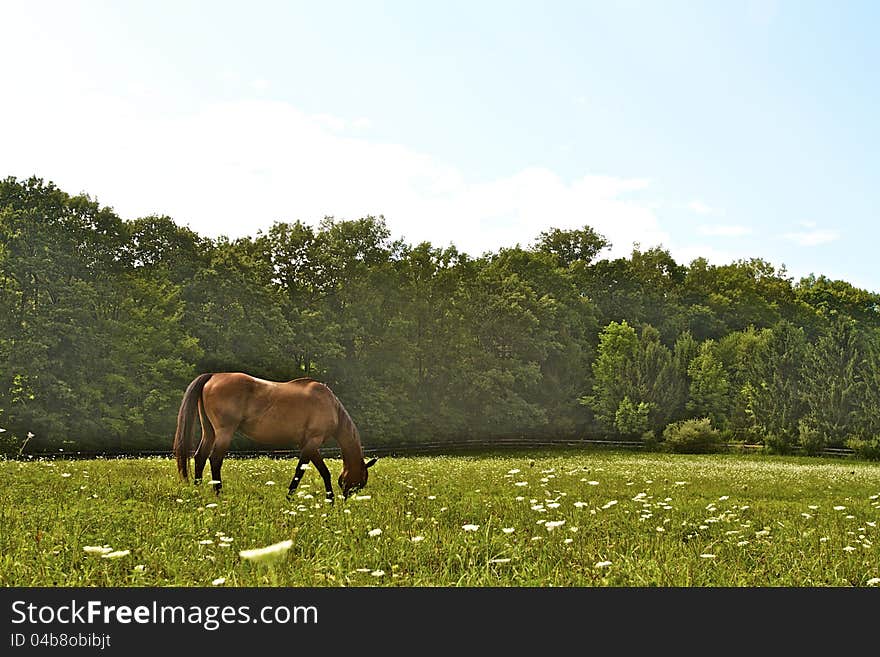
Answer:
xmin=0 ymin=0 xmax=880 ymax=292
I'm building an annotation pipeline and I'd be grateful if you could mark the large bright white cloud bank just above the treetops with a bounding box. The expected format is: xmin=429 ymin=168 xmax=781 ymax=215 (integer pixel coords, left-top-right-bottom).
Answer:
xmin=0 ymin=88 xmax=669 ymax=255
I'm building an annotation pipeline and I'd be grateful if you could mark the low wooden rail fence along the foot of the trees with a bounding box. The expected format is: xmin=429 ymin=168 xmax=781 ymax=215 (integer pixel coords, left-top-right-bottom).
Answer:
xmin=13 ymin=437 xmax=854 ymax=459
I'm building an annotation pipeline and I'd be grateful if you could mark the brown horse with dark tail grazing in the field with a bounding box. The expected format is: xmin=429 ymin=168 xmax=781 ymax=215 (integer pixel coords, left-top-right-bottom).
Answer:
xmin=174 ymin=372 xmax=376 ymax=502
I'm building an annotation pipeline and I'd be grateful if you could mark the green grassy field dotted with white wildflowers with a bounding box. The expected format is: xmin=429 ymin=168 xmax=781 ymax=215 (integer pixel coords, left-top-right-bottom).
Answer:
xmin=0 ymin=450 xmax=880 ymax=587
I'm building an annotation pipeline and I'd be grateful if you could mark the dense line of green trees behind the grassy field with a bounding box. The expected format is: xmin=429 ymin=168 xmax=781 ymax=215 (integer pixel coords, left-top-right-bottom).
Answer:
xmin=0 ymin=177 xmax=880 ymax=452
